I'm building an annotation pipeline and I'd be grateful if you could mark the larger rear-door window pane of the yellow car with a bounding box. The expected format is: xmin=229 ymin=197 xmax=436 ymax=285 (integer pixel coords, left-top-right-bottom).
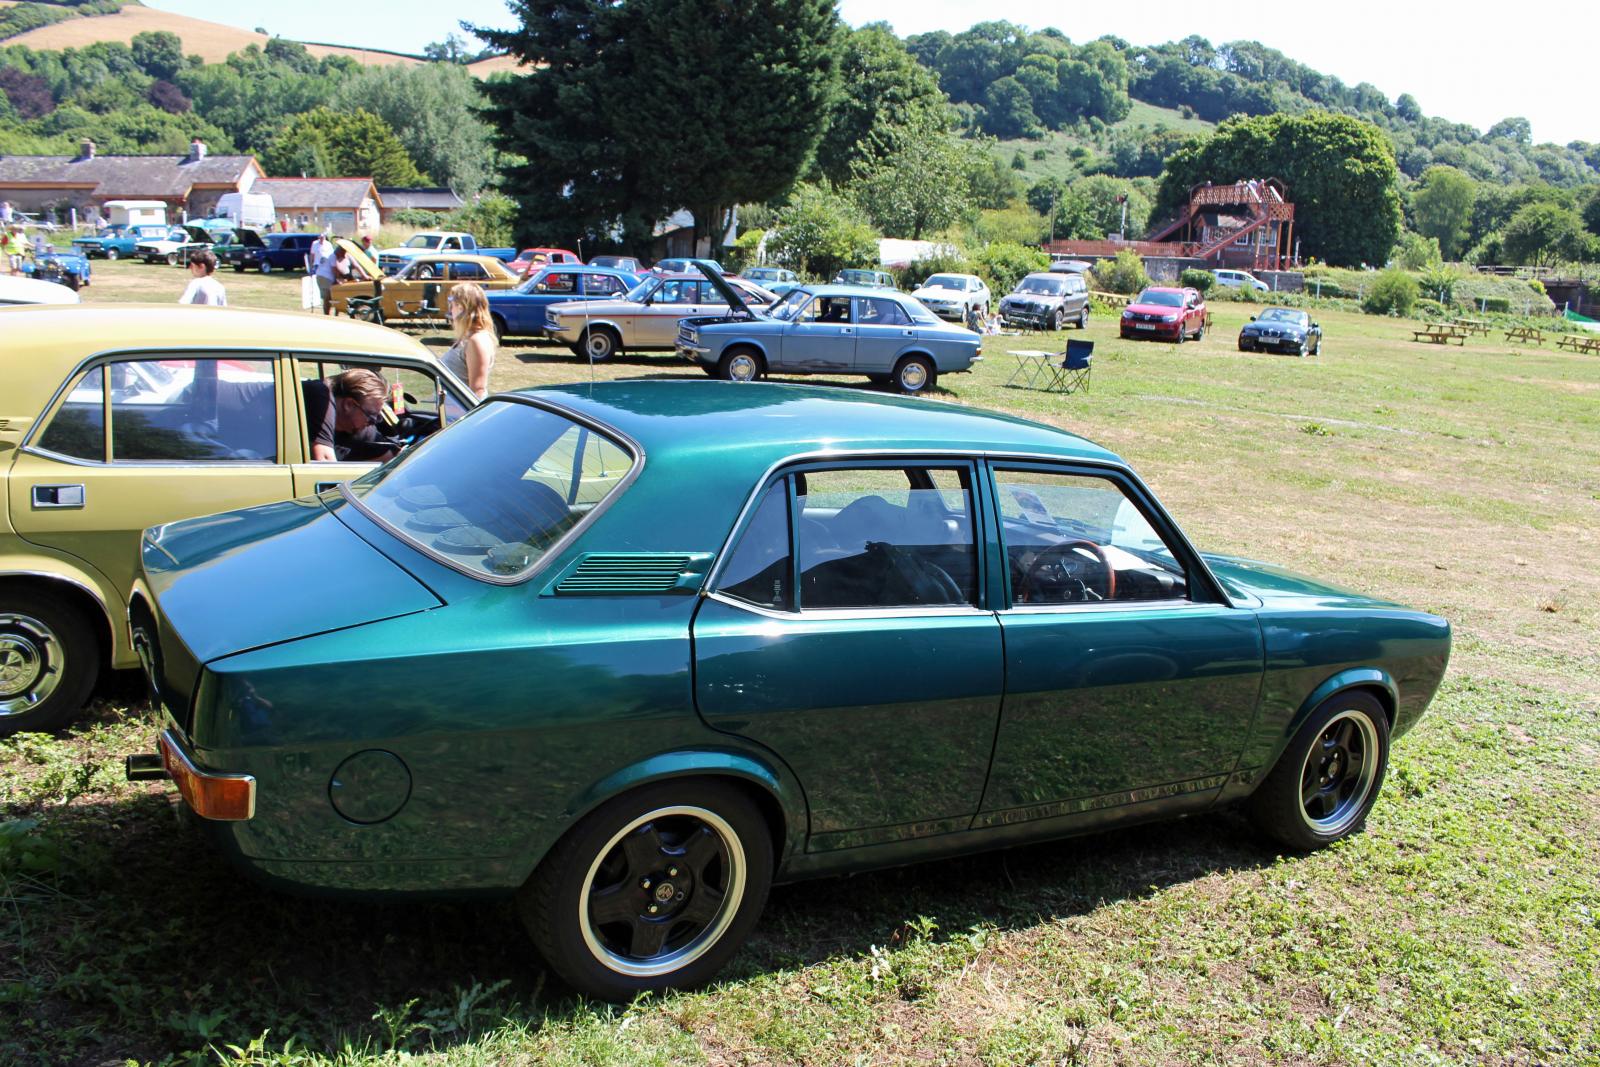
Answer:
xmin=106 ymin=357 xmax=278 ymax=462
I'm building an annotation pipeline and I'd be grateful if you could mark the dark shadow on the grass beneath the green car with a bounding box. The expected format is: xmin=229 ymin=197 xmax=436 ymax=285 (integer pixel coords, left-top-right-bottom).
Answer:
xmin=0 ymin=787 xmax=1274 ymax=1062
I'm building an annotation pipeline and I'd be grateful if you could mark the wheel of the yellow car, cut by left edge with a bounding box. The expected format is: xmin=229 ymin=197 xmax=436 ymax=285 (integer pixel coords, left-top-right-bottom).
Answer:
xmin=0 ymin=590 xmax=101 ymax=737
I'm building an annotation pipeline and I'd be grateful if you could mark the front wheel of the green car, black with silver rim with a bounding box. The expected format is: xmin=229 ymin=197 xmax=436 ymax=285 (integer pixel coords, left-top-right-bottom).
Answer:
xmin=1250 ymin=689 xmax=1389 ymax=851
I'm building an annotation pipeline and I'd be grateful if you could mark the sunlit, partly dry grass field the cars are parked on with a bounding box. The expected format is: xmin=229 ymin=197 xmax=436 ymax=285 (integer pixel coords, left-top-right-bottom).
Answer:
xmin=9 ymin=264 xmax=1600 ymax=1065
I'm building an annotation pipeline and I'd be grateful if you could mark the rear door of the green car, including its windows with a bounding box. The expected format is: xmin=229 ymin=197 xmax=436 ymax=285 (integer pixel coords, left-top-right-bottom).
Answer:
xmin=693 ymin=459 xmax=1003 ymax=851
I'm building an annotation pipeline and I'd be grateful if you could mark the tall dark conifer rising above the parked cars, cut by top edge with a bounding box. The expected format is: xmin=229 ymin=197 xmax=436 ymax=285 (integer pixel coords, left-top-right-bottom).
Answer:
xmin=472 ymin=0 xmax=840 ymax=251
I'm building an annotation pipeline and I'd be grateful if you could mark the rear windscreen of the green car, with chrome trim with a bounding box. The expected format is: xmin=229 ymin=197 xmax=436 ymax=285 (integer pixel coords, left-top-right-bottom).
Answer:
xmin=349 ymin=400 xmax=638 ymax=581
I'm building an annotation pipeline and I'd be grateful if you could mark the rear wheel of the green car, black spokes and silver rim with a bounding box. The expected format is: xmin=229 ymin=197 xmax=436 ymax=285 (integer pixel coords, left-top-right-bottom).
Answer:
xmin=517 ymin=779 xmax=773 ymax=1001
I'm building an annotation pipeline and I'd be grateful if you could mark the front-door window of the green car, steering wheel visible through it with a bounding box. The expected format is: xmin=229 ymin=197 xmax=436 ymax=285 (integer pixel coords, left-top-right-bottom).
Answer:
xmin=994 ymin=469 xmax=1189 ymax=605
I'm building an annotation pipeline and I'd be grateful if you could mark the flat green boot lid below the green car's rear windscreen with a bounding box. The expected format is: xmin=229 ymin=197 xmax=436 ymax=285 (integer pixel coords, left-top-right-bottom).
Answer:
xmin=139 ymin=498 xmax=443 ymax=665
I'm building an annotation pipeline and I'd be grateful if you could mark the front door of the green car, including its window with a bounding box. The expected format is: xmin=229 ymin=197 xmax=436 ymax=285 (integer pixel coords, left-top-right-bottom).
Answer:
xmin=979 ymin=462 xmax=1264 ymax=824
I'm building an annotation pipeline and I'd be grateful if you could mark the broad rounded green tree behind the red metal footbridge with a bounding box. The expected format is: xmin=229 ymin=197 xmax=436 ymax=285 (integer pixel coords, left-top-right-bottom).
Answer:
xmin=1155 ymin=112 xmax=1402 ymax=266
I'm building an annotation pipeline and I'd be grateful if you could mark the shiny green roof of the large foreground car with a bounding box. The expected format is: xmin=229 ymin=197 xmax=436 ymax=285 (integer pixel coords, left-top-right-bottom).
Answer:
xmin=522 ymin=381 xmax=1120 ymax=470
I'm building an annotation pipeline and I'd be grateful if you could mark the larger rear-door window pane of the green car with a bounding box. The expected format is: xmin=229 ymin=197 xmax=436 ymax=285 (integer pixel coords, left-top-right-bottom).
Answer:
xmin=794 ymin=467 xmax=978 ymax=611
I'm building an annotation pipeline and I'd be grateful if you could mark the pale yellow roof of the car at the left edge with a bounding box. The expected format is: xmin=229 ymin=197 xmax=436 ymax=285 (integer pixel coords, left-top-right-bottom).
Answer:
xmin=0 ymin=304 xmax=430 ymax=424
